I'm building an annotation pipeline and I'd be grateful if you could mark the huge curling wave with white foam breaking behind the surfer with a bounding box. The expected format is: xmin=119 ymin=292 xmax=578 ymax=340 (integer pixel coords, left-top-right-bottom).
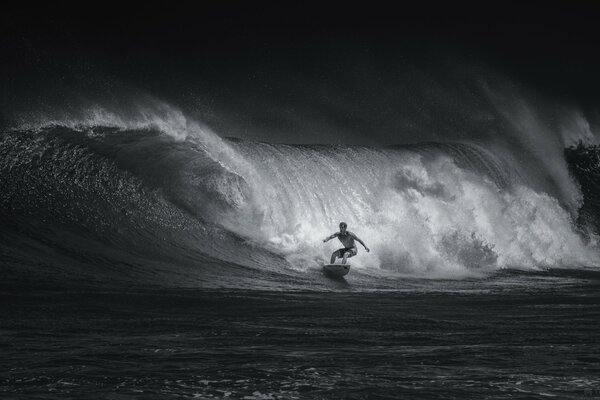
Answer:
xmin=0 ymin=111 xmax=598 ymax=288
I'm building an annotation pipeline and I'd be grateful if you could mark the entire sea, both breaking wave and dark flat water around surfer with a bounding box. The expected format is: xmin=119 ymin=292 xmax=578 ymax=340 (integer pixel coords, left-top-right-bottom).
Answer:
xmin=0 ymin=112 xmax=600 ymax=399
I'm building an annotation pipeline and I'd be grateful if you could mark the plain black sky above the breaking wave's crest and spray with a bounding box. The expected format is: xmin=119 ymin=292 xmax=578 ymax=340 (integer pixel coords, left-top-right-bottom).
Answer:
xmin=0 ymin=1 xmax=600 ymax=142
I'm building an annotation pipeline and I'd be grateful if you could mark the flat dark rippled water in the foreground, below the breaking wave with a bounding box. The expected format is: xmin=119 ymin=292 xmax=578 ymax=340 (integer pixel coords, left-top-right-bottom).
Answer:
xmin=0 ymin=279 xmax=600 ymax=399
